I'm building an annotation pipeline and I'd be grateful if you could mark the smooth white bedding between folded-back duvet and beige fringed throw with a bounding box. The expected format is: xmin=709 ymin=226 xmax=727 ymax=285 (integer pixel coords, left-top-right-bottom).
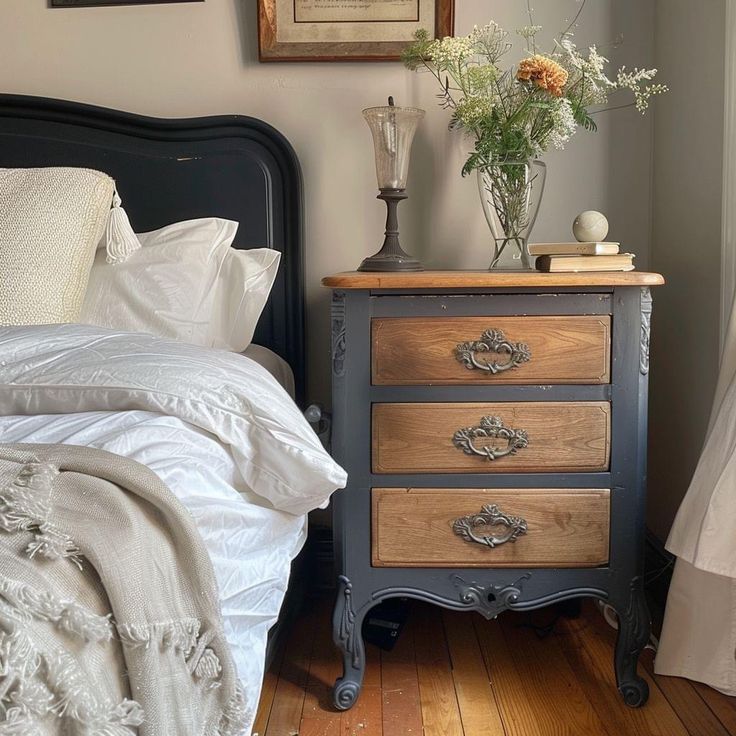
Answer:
xmin=0 ymin=411 xmax=306 ymax=732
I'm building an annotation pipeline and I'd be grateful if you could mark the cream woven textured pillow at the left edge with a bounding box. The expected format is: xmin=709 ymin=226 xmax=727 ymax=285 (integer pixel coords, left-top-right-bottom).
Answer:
xmin=0 ymin=167 xmax=115 ymax=325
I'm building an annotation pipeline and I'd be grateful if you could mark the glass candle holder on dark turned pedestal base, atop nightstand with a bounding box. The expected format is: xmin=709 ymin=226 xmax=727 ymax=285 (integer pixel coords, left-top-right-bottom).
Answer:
xmin=358 ymin=97 xmax=424 ymax=271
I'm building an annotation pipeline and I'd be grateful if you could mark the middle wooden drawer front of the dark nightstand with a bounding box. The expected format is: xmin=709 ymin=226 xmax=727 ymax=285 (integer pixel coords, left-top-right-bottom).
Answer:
xmin=372 ymin=401 xmax=611 ymax=473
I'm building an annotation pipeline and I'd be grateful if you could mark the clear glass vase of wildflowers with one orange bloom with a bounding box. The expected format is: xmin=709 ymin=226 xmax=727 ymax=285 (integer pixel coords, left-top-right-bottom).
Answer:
xmin=403 ymin=10 xmax=667 ymax=268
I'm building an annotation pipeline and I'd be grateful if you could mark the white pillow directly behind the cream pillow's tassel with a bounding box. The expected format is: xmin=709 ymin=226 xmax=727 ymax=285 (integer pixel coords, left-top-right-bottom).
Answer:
xmin=79 ymin=217 xmax=238 ymax=345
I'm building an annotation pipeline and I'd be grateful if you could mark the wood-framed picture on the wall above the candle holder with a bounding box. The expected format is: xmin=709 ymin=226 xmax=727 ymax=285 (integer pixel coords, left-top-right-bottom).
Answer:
xmin=258 ymin=0 xmax=455 ymax=61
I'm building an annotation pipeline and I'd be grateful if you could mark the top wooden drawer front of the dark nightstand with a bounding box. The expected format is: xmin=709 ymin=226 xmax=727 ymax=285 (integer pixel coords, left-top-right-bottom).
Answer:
xmin=371 ymin=316 xmax=611 ymax=385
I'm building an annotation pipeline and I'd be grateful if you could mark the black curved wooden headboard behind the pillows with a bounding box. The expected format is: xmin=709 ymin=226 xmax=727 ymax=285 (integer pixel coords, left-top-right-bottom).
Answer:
xmin=0 ymin=94 xmax=306 ymax=403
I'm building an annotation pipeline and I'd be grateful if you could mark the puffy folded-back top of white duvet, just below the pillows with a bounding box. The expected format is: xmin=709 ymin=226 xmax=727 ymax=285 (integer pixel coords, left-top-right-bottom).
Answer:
xmin=0 ymin=324 xmax=347 ymax=514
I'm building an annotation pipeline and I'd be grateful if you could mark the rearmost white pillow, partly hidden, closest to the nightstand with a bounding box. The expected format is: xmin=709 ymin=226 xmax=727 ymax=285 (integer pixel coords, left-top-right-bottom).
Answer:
xmin=207 ymin=248 xmax=281 ymax=353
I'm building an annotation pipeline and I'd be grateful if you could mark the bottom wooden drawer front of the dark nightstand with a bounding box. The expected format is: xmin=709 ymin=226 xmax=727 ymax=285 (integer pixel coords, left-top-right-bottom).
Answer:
xmin=372 ymin=488 xmax=610 ymax=567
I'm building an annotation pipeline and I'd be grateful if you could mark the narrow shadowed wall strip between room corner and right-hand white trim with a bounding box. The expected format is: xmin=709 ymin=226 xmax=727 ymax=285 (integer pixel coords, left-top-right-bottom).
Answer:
xmin=648 ymin=0 xmax=726 ymax=539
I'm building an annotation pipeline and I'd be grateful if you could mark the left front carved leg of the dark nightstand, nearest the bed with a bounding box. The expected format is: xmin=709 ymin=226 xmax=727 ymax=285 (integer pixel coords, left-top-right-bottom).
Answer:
xmin=332 ymin=575 xmax=369 ymax=710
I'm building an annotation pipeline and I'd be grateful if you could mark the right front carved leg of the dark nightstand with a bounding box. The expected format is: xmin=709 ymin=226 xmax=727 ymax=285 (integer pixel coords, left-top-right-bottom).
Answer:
xmin=614 ymin=577 xmax=651 ymax=708
